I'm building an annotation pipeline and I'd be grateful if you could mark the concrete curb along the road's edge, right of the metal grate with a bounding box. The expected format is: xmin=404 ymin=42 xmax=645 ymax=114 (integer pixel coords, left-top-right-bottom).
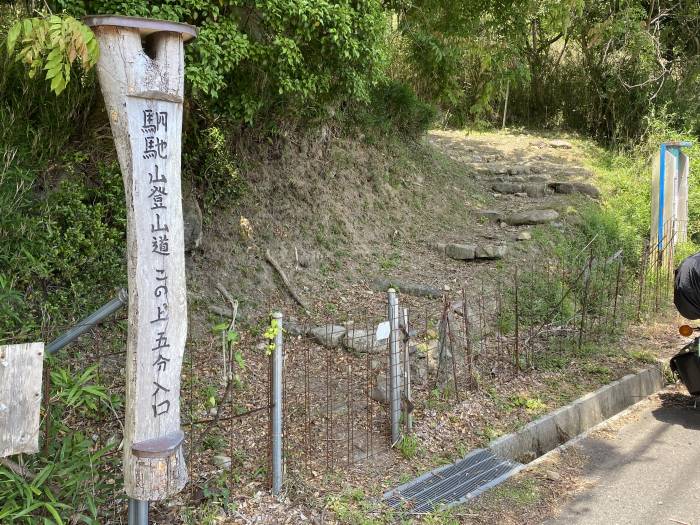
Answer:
xmin=489 ymin=366 xmax=664 ymax=463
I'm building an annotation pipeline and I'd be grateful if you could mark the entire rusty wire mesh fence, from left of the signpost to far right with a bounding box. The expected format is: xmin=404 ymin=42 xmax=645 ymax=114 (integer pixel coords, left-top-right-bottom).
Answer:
xmin=16 ymin=229 xmax=674 ymax=523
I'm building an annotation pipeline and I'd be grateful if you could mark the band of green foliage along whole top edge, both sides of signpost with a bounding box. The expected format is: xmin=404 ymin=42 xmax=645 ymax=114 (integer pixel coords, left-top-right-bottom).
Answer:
xmin=1 ymin=0 xmax=700 ymax=145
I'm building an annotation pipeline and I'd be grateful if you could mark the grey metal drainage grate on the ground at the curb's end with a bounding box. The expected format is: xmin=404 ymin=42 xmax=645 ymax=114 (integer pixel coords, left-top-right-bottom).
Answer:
xmin=384 ymin=449 xmax=524 ymax=513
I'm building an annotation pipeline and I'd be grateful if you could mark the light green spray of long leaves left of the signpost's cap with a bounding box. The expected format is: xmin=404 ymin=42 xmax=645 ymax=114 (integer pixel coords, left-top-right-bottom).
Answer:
xmin=7 ymin=15 xmax=99 ymax=95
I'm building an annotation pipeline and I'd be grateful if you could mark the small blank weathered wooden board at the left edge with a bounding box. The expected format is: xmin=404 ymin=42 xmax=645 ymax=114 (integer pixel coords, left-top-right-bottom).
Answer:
xmin=0 ymin=343 xmax=44 ymax=457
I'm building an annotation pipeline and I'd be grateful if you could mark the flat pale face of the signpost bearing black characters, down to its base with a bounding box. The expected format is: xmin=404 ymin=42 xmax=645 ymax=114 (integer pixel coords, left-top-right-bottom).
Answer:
xmin=126 ymin=97 xmax=187 ymax=499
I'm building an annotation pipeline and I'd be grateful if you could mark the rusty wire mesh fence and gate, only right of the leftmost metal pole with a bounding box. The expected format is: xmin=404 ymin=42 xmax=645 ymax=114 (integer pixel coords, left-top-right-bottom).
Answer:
xmin=266 ymin=231 xmax=673 ymax=486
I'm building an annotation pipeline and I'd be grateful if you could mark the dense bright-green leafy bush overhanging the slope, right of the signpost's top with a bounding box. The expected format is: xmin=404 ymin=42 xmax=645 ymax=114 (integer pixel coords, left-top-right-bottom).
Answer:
xmin=40 ymin=0 xmax=385 ymax=125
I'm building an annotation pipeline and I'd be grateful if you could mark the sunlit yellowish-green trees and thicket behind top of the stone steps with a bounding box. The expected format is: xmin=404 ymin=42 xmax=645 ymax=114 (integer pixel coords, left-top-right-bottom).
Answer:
xmin=389 ymin=0 xmax=700 ymax=145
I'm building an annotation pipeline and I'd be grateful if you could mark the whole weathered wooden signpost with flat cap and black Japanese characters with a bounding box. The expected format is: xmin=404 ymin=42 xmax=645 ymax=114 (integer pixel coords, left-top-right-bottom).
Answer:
xmin=84 ymin=16 xmax=196 ymax=508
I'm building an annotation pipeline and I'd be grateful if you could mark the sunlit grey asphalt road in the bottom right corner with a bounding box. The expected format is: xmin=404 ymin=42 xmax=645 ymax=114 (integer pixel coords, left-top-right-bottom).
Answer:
xmin=545 ymin=388 xmax=700 ymax=525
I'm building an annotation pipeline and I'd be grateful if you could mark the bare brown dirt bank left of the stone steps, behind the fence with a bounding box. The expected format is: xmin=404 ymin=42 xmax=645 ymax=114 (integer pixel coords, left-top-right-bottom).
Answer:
xmin=188 ymin=131 xmax=591 ymax=330
